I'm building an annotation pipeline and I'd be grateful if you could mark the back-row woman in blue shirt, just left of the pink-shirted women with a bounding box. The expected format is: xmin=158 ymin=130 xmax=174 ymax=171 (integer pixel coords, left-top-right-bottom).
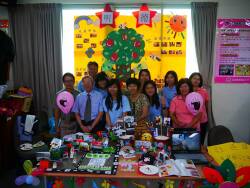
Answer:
xmin=162 ymin=70 xmax=178 ymax=116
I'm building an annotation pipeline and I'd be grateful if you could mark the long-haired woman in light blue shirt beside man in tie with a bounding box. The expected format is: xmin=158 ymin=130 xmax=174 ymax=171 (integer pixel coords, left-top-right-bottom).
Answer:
xmin=103 ymin=79 xmax=131 ymax=129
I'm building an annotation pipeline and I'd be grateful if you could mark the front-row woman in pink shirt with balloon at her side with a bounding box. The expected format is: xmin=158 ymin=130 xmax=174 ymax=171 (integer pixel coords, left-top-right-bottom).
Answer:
xmin=169 ymin=78 xmax=202 ymax=130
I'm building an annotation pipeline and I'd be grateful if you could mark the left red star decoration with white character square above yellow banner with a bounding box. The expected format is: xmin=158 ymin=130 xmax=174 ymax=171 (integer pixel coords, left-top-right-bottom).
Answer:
xmin=96 ymin=4 xmax=119 ymax=28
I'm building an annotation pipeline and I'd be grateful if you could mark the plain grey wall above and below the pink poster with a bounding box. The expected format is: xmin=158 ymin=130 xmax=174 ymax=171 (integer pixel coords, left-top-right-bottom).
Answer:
xmin=212 ymin=0 xmax=250 ymax=143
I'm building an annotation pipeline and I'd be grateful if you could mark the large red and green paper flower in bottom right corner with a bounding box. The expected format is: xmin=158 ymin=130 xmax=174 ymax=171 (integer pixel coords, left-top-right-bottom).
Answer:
xmin=202 ymin=159 xmax=250 ymax=188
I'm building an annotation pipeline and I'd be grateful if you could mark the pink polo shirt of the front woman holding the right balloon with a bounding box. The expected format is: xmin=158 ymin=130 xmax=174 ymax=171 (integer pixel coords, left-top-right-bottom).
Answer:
xmin=169 ymin=95 xmax=200 ymax=130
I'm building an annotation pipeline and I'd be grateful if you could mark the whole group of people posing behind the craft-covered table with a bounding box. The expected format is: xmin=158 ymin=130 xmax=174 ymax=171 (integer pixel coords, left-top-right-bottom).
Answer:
xmin=55 ymin=62 xmax=209 ymax=142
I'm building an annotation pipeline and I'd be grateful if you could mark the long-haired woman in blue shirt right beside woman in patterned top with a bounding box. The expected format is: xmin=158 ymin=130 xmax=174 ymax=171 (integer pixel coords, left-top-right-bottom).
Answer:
xmin=143 ymin=80 xmax=166 ymax=122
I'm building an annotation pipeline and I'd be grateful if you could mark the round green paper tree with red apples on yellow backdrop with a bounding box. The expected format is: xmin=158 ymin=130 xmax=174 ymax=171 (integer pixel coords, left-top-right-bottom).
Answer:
xmin=102 ymin=27 xmax=145 ymax=80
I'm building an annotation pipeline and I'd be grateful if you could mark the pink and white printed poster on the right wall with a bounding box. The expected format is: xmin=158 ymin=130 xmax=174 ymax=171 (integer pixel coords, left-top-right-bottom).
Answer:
xmin=215 ymin=19 xmax=250 ymax=84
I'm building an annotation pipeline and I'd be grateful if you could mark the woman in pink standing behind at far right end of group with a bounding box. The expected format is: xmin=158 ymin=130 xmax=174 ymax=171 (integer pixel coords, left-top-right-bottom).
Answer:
xmin=189 ymin=72 xmax=209 ymax=144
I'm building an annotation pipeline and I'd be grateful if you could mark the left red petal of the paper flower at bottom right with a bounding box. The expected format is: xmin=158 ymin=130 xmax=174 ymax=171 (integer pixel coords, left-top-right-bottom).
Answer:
xmin=203 ymin=167 xmax=224 ymax=184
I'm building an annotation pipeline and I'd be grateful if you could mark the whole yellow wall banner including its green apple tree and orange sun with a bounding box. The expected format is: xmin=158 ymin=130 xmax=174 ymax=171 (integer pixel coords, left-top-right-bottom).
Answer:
xmin=74 ymin=13 xmax=187 ymax=87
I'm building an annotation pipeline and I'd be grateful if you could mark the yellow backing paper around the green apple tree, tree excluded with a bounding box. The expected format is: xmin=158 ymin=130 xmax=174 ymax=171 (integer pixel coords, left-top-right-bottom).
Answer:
xmin=74 ymin=14 xmax=187 ymax=84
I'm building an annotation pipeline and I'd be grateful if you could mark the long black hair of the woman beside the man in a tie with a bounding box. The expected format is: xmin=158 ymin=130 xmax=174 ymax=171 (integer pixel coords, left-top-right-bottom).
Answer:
xmin=105 ymin=79 xmax=122 ymax=110
